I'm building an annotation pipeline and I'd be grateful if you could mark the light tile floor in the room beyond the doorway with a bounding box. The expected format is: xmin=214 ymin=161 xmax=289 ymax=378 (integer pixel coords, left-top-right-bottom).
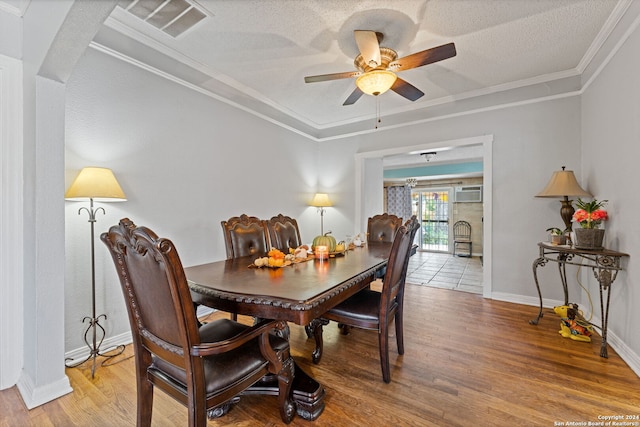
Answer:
xmin=407 ymin=252 xmax=482 ymax=294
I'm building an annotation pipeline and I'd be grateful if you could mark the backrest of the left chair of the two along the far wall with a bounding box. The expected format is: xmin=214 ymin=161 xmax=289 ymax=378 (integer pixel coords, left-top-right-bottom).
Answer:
xmin=220 ymin=214 xmax=269 ymax=259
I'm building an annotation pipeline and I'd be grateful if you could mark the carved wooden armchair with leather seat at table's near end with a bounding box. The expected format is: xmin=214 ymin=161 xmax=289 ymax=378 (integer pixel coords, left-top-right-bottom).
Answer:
xmin=100 ymin=218 xmax=295 ymax=427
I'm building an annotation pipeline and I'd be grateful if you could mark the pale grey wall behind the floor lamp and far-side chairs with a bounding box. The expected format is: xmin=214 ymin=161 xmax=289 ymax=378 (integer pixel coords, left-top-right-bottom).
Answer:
xmin=65 ymin=49 xmax=318 ymax=351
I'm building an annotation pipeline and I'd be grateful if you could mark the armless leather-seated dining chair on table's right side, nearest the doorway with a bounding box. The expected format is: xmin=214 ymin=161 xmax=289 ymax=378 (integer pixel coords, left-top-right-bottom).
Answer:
xmin=312 ymin=216 xmax=419 ymax=383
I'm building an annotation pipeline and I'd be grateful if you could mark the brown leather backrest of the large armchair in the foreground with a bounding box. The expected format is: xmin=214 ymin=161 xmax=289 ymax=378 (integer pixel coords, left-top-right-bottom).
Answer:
xmin=100 ymin=218 xmax=203 ymax=374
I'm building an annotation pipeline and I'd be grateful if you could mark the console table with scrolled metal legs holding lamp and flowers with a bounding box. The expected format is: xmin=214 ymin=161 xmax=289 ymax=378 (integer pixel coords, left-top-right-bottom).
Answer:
xmin=529 ymin=242 xmax=629 ymax=357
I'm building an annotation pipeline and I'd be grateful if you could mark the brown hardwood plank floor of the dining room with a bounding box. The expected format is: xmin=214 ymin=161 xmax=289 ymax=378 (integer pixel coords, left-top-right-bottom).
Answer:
xmin=0 ymin=285 xmax=640 ymax=427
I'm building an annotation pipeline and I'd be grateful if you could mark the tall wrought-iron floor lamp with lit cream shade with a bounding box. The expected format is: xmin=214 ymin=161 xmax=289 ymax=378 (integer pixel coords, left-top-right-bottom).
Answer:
xmin=64 ymin=167 xmax=127 ymax=378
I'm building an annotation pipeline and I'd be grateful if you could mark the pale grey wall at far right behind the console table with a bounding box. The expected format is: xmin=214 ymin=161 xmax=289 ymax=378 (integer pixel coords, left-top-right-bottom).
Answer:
xmin=582 ymin=14 xmax=640 ymax=368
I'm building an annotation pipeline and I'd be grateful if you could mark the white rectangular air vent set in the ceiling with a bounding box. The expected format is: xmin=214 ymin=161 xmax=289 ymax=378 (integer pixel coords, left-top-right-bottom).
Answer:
xmin=126 ymin=0 xmax=207 ymax=38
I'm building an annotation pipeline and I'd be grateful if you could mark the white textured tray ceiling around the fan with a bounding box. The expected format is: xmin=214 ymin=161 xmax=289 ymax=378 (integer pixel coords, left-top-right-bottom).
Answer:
xmin=94 ymin=0 xmax=618 ymax=144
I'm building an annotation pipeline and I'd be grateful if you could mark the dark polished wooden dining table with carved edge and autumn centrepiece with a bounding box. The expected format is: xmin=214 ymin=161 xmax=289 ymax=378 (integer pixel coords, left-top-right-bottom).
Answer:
xmin=184 ymin=242 xmax=392 ymax=420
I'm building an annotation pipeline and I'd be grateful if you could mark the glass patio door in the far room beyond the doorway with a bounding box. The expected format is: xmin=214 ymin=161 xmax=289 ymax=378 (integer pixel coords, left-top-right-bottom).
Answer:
xmin=411 ymin=188 xmax=452 ymax=252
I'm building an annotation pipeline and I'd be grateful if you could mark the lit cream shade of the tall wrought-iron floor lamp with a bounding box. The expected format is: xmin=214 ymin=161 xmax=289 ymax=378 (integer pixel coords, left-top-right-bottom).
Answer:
xmin=64 ymin=167 xmax=127 ymax=202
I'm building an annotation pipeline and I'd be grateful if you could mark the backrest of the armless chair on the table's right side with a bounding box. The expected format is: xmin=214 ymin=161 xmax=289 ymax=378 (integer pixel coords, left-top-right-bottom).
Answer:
xmin=380 ymin=215 xmax=419 ymax=322
